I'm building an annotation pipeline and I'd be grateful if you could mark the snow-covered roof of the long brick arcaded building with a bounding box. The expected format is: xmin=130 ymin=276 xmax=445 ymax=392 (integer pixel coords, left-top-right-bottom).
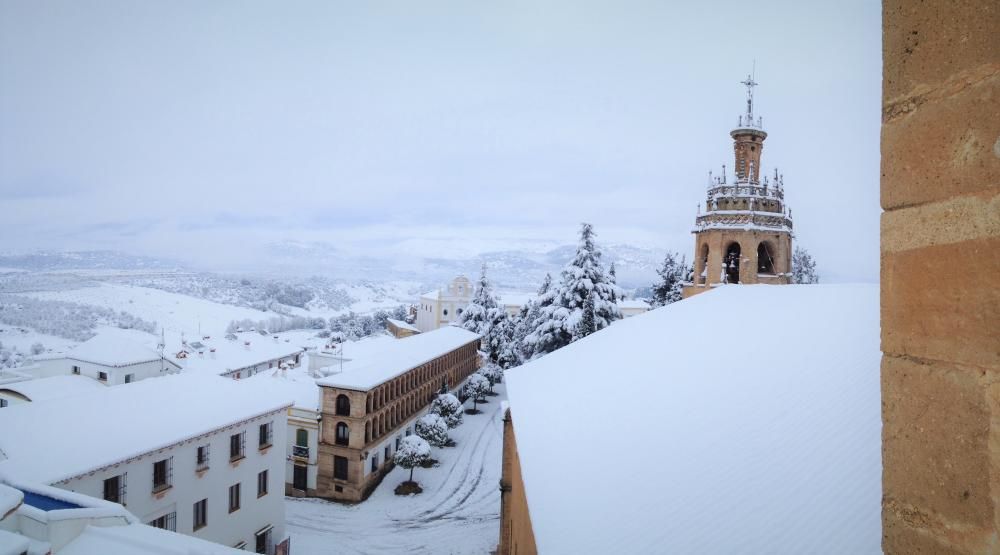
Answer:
xmin=316 ymin=326 xmax=479 ymax=391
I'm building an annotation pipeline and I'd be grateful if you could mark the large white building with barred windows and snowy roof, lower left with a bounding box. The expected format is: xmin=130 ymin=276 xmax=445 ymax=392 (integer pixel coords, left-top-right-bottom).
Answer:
xmin=0 ymin=373 xmax=292 ymax=554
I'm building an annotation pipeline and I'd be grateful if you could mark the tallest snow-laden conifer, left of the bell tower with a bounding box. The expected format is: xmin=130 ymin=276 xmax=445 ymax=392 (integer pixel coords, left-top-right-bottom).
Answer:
xmin=528 ymin=223 xmax=622 ymax=356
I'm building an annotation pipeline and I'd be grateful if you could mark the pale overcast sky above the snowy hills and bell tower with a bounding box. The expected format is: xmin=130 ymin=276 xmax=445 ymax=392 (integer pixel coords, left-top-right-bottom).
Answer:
xmin=0 ymin=0 xmax=881 ymax=280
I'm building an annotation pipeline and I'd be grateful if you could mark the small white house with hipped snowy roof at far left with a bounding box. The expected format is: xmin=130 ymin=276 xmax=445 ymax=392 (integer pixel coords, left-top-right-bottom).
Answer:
xmin=33 ymin=329 xmax=181 ymax=385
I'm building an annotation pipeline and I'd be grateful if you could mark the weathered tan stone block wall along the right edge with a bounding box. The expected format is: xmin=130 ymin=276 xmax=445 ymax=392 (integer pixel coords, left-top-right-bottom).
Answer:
xmin=881 ymin=0 xmax=1000 ymax=553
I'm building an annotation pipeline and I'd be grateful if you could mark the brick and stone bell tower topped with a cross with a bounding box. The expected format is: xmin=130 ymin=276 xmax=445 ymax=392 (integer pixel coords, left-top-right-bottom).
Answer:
xmin=684 ymin=76 xmax=792 ymax=297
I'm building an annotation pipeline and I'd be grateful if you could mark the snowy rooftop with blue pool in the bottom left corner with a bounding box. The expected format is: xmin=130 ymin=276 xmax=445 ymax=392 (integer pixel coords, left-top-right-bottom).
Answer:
xmin=0 ymin=482 xmax=245 ymax=555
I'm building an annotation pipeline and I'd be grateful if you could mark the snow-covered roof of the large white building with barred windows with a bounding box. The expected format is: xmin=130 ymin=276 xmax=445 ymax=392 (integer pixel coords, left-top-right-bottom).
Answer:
xmin=0 ymin=373 xmax=292 ymax=484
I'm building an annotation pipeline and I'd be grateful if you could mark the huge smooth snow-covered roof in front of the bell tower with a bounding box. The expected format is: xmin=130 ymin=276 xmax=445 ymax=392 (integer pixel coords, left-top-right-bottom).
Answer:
xmin=505 ymin=285 xmax=882 ymax=553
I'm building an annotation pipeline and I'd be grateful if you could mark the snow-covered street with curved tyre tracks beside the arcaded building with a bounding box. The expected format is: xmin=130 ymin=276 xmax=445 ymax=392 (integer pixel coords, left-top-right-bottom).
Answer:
xmin=285 ymin=384 xmax=506 ymax=555
